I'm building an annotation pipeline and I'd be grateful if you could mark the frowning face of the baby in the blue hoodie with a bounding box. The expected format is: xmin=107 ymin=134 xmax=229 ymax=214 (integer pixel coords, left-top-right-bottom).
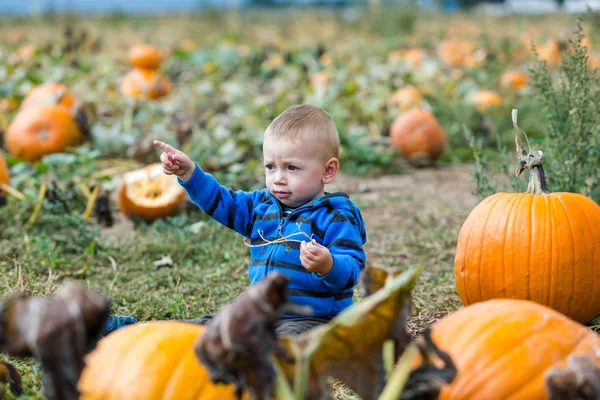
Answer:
xmin=263 ymin=134 xmax=326 ymax=207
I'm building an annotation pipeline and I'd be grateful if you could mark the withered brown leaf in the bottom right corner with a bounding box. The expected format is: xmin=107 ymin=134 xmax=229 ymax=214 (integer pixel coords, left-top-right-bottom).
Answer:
xmin=546 ymin=354 xmax=600 ymax=400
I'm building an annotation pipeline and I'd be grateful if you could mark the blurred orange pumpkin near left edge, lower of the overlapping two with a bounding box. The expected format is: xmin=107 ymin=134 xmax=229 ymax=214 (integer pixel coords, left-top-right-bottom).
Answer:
xmin=4 ymin=105 xmax=85 ymax=162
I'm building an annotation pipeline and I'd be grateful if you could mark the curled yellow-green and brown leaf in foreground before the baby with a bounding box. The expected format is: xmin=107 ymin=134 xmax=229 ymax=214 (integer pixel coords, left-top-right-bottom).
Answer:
xmin=280 ymin=266 xmax=420 ymax=400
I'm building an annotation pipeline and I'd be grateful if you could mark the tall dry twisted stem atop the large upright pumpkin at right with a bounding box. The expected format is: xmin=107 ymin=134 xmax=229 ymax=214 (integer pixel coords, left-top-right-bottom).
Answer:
xmin=512 ymin=109 xmax=548 ymax=194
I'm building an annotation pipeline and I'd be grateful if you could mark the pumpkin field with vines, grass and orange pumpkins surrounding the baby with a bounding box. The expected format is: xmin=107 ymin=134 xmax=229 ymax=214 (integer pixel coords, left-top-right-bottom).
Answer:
xmin=0 ymin=2 xmax=600 ymax=400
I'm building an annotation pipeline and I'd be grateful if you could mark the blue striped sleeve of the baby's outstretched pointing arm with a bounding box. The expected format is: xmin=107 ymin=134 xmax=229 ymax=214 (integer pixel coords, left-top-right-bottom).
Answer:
xmin=179 ymin=164 xmax=264 ymax=236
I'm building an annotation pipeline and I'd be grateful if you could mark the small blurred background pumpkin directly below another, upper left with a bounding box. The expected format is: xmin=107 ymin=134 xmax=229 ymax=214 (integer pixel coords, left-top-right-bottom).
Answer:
xmin=121 ymin=68 xmax=172 ymax=100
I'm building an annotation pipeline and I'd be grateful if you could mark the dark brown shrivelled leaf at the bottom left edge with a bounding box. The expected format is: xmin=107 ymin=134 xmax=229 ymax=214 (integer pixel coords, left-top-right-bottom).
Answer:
xmin=0 ymin=284 xmax=110 ymax=400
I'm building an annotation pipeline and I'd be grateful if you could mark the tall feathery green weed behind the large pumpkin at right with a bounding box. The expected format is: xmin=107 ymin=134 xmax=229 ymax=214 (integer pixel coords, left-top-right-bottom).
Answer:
xmin=530 ymin=20 xmax=600 ymax=203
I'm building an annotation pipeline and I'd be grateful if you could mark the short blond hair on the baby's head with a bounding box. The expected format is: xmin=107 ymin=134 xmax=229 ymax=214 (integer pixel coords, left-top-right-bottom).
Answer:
xmin=265 ymin=104 xmax=340 ymax=159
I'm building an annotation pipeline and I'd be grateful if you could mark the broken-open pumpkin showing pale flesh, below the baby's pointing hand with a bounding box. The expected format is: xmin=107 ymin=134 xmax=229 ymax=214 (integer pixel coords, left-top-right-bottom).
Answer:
xmin=117 ymin=163 xmax=186 ymax=222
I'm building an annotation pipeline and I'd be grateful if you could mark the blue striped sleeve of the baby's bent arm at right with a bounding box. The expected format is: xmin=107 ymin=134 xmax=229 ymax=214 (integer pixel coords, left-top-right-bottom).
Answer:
xmin=313 ymin=212 xmax=366 ymax=290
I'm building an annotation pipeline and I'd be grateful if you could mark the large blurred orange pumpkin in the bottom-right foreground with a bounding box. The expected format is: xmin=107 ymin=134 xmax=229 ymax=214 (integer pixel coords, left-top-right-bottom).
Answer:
xmin=422 ymin=299 xmax=600 ymax=400
